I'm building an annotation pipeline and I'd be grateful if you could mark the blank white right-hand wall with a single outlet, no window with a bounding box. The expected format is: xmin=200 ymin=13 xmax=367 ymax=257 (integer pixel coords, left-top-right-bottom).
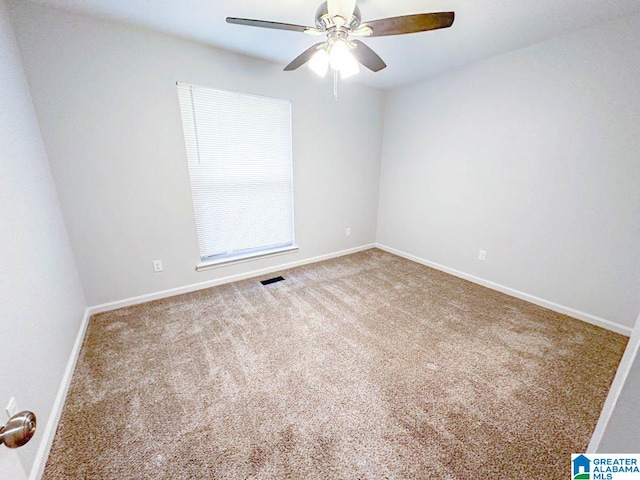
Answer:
xmin=378 ymin=16 xmax=640 ymax=328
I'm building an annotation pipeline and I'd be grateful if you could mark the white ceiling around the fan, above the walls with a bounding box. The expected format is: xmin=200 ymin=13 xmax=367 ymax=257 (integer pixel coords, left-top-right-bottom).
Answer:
xmin=22 ymin=0 xmax=640 ymax=88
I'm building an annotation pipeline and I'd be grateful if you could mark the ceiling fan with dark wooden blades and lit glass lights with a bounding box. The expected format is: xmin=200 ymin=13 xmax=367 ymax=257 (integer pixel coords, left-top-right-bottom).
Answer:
xmin=227 ymin=0 xmax=454 ymax=78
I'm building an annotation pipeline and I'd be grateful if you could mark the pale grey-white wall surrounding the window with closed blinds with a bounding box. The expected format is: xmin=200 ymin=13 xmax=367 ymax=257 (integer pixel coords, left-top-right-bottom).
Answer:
xmin=10 ymin=2 xmax=384 ymax=305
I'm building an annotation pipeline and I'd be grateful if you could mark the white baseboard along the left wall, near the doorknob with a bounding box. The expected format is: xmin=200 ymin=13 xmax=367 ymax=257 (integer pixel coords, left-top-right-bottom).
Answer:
xmin=29 ymin=308 xmax=91 ymax=480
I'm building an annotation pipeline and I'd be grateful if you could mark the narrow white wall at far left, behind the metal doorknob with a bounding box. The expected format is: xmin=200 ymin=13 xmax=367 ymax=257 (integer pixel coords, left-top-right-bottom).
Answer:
xmin=0 ymin=0 xmax=86 ymax=478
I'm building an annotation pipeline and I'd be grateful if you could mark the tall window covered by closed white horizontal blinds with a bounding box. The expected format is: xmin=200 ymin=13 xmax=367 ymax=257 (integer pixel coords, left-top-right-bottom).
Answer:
xmin=178 ymin=83 xmax=297 ymax=267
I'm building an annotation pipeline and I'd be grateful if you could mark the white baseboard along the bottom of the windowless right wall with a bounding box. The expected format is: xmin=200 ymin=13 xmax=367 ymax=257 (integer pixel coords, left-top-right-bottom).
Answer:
xmin=375 ymin=243 xmax=632 ymax=337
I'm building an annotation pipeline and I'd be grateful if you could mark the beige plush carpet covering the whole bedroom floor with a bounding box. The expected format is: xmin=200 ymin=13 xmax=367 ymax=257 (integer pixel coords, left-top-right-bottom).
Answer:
xmin=44 ymin=250 xmax=626 ymax=479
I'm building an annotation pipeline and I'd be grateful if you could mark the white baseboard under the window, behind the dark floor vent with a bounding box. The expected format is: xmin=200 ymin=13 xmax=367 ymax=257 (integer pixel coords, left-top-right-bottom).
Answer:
xmin=89 ymin=243 xmax=375 ymax=316
